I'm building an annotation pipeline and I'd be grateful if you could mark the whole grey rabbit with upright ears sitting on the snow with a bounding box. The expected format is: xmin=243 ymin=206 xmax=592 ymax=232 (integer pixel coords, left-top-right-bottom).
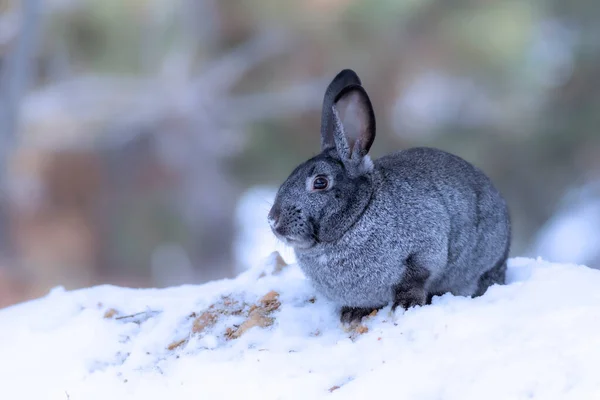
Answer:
xmin=268 ymin=69 xmax=511 ymax=323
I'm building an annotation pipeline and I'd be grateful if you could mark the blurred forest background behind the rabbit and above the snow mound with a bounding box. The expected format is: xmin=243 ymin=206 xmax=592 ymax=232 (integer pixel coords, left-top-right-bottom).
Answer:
xmin=0 ymin=0 xmax=600 ymax=307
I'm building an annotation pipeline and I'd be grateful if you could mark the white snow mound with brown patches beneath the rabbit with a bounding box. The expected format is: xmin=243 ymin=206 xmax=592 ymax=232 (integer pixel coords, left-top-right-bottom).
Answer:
xmin=0 ymin=259 xmax=600 ymax=400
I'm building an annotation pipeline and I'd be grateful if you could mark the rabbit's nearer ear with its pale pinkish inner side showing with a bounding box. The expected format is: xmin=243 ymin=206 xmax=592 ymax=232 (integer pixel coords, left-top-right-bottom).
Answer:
xmin=332 ymin=85 xmax=375 ymax=164
